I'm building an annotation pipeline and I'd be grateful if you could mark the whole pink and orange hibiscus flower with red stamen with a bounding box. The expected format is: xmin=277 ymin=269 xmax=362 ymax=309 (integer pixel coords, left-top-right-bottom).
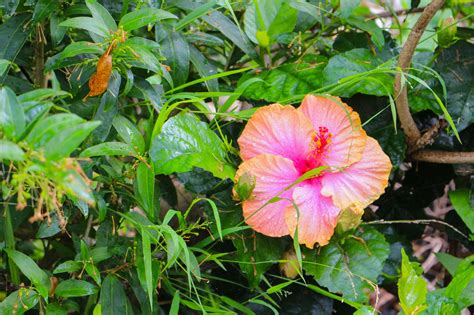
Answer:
xmin=235 ymin=95 xmax=392 ymax=248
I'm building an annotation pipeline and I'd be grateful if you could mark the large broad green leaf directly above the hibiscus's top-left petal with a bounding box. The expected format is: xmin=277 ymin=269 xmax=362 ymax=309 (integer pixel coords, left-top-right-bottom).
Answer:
xmin=239 ymin=57 xmax=326 ymax=102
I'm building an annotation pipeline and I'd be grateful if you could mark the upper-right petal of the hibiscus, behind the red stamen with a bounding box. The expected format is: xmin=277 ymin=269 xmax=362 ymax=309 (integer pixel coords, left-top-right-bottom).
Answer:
xmin=298 ymin=95 xmax=367 ymax=168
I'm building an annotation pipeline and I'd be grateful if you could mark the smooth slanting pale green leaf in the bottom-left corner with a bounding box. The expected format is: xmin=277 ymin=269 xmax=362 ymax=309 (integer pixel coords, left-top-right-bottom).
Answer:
xmin=5 ymin=249 xmax=50 ymax=299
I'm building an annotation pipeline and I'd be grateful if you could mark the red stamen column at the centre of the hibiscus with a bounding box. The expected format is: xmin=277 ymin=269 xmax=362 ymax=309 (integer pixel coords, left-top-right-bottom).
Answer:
xmin=298 ymin=127 xmax=332 ymax=174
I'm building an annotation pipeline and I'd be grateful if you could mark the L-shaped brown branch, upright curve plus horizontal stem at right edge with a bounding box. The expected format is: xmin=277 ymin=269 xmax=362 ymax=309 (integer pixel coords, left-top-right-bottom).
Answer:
xmin=393 ymin=0 xmax=474 ymax=164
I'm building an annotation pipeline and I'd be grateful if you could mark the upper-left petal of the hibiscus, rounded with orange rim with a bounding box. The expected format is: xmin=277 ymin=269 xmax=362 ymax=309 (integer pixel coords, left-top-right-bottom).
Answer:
xmin=238 ymin=104 xmax=313 ymax=162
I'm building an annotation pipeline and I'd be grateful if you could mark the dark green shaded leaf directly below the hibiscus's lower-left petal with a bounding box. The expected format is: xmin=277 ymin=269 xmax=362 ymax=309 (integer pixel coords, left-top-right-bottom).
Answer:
xmin=232 ymin=231 xmax=285 ymax=287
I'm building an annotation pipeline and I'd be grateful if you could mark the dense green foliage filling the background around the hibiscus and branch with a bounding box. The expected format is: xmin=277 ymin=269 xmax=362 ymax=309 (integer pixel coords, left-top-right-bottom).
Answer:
xmin=0 ymin=0 xmax=474 ymax=314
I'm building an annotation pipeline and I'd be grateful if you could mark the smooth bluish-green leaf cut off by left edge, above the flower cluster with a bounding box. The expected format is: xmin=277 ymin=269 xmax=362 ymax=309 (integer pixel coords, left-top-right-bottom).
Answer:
xmin=0 ymin=86 xmax=25 ymax=139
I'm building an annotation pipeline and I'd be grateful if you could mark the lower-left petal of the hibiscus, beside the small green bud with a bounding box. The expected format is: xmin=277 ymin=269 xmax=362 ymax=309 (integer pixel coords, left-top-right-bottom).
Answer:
xmin=235 ymin=154 xmax=299 ymax=236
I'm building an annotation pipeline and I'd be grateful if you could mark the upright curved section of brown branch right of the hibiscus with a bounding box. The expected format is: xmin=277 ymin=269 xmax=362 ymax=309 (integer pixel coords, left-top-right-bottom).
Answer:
xmin=394 ymin=0 xmax=444 ymax=147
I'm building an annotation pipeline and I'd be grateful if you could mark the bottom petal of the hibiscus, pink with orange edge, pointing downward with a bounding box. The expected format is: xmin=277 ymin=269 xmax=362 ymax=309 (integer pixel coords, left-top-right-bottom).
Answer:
xmin=285 ymin=181 xmax=340 ymax=248
